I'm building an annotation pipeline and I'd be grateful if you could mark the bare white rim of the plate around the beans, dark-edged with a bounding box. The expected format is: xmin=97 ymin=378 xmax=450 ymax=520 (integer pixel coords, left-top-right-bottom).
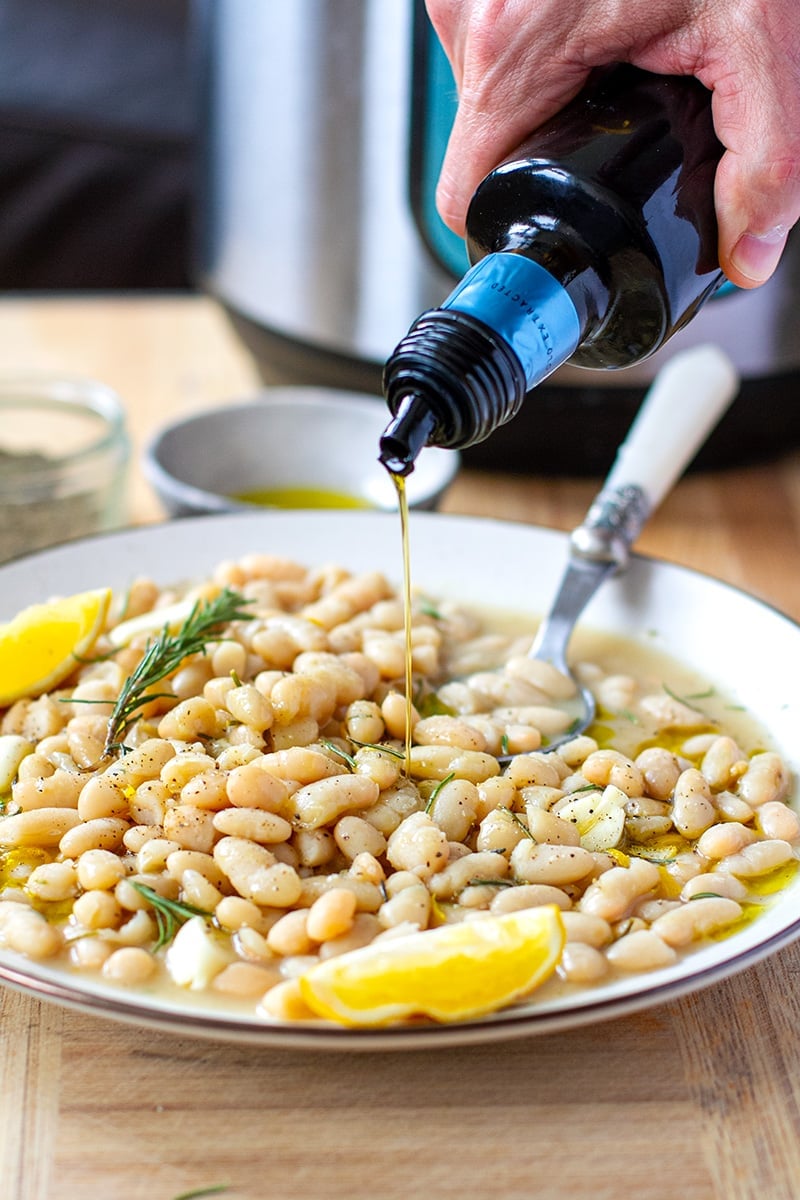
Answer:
xmin=0 ymin=512 xmax=800 ymax=1049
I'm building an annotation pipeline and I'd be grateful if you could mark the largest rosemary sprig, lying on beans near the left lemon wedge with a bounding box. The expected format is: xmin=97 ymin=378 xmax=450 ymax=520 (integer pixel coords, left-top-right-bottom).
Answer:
xmin=103 ymin=588 xmax=252 ymax=757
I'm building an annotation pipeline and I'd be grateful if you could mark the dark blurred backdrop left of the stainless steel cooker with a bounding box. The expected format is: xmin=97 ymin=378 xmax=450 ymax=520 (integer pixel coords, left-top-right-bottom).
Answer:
xmin=0 ymin=0 xmax=191 ymax=292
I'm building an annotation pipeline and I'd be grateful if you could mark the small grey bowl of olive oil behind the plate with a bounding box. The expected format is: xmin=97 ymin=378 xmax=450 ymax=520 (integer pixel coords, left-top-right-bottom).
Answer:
xmin=142 ymin=388 xmax=459 ymax=516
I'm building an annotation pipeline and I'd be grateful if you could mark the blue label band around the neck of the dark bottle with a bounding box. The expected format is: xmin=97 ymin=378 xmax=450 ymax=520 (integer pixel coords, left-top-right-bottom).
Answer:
xmin=441 ymin=253 xmax=581 ymax=389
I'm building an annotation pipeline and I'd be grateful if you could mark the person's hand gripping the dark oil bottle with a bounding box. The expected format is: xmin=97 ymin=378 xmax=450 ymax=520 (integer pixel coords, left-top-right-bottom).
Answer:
xmin=426 ymin=0 xmax=800 ymax=288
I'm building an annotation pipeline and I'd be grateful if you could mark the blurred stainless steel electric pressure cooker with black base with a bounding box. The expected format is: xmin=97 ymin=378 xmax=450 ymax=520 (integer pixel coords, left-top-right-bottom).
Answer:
xmin=198 ymin=0 xmax=800 ymax=475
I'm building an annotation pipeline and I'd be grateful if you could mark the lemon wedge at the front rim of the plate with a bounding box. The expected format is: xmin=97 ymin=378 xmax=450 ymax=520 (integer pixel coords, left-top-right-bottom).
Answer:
xmin=299 ymin=905 xmax=565 ymax=1026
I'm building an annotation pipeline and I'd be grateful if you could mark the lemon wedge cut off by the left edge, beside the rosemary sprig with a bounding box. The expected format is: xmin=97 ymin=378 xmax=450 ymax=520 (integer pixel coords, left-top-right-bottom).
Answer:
xmin=0 ymin=588 xmax=112 ymax=708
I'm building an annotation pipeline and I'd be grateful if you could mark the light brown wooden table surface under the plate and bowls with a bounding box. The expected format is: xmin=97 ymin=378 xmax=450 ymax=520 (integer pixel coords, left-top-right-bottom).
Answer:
xmin=0 ymin=298 xmax=800 ymax=1200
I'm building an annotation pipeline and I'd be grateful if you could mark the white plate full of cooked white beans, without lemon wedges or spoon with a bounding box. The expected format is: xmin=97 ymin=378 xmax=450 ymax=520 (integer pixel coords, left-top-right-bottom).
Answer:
xmin=0 ymin=511 xmax=800 ymax=1049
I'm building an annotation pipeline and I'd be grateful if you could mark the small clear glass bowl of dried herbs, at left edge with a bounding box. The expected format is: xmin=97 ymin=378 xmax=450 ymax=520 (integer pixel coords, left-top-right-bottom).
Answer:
xmin=0 ymin=376 xmax=130 ymax=562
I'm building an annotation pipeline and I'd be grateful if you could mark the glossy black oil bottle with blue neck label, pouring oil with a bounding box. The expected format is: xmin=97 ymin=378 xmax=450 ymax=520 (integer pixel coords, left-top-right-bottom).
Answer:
xmin=380 ymin=65 xmax=723 ymax=475
